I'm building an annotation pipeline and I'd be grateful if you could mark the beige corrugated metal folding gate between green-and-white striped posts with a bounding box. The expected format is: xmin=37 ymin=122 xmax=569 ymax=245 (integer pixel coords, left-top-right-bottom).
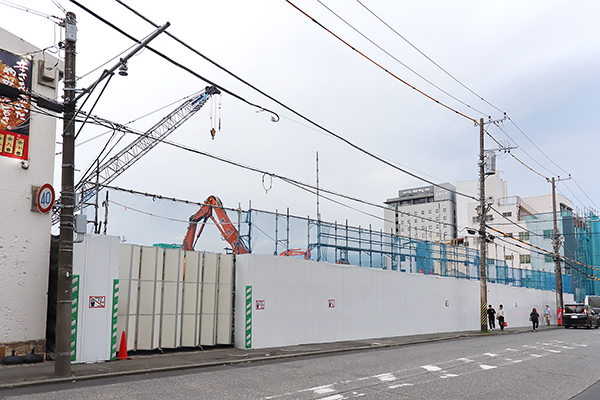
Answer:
xmin=118 ymin=245 xmax=234 ymax=350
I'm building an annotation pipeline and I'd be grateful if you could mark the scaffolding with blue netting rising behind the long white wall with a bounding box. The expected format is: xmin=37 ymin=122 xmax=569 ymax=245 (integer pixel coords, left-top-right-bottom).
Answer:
xmin=237 ymin=209 xmax=574 ymax=293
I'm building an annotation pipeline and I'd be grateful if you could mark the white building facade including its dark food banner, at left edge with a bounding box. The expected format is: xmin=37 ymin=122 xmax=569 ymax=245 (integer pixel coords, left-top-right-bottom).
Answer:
xmin=0 ymin=28 xmax=62 ymax=356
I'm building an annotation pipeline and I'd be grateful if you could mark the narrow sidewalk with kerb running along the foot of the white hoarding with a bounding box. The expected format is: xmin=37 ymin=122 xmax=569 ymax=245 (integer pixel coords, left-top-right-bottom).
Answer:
xmin=0 ymin=326 xmax=559 ymax=390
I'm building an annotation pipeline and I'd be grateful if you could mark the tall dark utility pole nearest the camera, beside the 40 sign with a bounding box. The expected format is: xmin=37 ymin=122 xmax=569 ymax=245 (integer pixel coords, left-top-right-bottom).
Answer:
xmin=54 ymin=12 xmax=77 ymax=376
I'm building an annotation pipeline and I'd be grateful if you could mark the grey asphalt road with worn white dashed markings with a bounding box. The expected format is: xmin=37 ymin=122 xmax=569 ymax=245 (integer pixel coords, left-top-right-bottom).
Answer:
xmin=0 ymin=329 xmax=600 ymax=400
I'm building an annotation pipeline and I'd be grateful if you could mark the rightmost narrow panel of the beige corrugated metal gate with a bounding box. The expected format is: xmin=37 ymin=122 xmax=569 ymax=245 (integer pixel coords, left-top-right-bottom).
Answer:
xmin=217 ymin=255 xmax=233 ymax=344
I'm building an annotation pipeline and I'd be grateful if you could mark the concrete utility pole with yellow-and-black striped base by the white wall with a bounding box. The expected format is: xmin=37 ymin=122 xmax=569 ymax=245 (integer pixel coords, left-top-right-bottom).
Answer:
xmin=478 ymin=118 xmax=488 ymax=332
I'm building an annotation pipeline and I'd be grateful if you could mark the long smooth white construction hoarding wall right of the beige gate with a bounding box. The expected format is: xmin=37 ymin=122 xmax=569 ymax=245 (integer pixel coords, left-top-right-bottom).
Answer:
xmin=235 ymin=254 xmax=572 ymax=348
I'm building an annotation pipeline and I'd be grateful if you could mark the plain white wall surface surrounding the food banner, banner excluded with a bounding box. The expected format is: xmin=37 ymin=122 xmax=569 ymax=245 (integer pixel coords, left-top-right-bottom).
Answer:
xmin=0 ymin=29 xmax=62 ymax=351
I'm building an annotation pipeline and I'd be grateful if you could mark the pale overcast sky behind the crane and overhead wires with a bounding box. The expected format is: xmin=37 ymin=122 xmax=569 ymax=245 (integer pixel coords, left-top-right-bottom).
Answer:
xmin=0 ymin=0 xmax=600 ymax=250
